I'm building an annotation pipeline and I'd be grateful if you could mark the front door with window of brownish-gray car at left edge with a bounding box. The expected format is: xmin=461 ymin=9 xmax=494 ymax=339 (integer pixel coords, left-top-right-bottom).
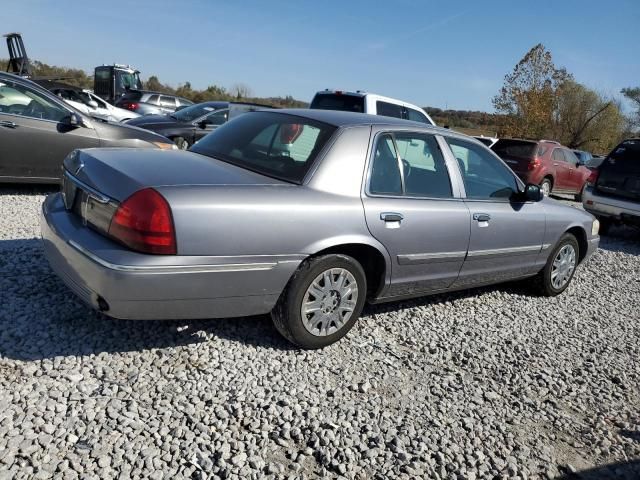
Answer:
xmin=0 ymin=81 xmax=100 ymax=180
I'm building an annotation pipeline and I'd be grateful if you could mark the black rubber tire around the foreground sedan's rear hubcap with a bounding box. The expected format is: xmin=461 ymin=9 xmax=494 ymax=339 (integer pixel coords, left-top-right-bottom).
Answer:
xmin=271 ymin=255 xmax=367 ymax=350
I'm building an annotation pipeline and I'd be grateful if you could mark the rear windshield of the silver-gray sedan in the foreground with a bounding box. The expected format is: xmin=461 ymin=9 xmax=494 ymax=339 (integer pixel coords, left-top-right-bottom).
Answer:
xmin=191 ymin=112 xmax=336 ymax=183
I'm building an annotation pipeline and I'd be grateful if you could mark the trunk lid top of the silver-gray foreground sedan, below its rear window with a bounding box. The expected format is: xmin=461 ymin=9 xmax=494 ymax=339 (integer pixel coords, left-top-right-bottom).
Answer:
xmin=64 ymin=148 xmax=288 ymax=201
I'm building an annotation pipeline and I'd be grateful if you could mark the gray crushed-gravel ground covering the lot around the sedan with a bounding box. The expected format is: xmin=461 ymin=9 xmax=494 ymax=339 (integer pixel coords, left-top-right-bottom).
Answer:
xmin=0 ymin=187 xmax=640 ymax=479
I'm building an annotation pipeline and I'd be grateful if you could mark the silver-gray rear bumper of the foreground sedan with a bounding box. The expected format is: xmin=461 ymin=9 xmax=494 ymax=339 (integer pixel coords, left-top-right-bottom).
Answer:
xmin=40 ymin=194 xmax=302 ymax=320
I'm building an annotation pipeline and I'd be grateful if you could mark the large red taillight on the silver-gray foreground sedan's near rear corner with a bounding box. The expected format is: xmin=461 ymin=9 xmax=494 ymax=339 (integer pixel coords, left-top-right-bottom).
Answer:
xmin=109 ymin=188 xmax=177 ymax=255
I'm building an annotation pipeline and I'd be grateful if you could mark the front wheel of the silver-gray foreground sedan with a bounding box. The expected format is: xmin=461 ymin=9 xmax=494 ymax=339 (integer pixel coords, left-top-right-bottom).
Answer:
xmin=538 ymin=233 xmax=580 ymax=297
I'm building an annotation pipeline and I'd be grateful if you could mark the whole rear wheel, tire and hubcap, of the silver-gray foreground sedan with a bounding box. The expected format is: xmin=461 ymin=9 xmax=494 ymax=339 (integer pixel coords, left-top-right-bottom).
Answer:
xmin=271 ymin=255 xmax=367 ymax=349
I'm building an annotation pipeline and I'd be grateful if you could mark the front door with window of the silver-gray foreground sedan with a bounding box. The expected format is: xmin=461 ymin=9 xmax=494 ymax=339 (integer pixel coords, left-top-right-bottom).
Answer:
xmin=447 ymin=137 xmax=545 ymax=287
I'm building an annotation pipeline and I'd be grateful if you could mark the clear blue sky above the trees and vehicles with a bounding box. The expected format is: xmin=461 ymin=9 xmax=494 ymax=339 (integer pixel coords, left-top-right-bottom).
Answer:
xmin=5 ymin=0 xmax=640 ymax=111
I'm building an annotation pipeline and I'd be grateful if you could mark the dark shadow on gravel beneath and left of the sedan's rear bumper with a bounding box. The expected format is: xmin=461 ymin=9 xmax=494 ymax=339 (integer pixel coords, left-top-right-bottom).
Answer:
xmin=0 ymin=238 xmax=293 ymax=360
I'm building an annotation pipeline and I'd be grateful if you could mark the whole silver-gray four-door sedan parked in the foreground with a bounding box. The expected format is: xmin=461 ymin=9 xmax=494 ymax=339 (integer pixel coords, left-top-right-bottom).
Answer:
xmin=42 ymin=110 xmax=599 ymax=348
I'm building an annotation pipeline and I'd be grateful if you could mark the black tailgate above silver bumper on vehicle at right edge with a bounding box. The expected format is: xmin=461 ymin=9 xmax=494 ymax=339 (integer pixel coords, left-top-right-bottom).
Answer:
xmin=596 ymin=140 xmax=640 ymax=200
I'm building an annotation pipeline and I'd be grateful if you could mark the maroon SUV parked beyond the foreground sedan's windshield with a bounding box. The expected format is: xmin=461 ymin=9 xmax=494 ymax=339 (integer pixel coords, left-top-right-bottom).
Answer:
xmin=491 ymin=138 xmax=591 ymax=200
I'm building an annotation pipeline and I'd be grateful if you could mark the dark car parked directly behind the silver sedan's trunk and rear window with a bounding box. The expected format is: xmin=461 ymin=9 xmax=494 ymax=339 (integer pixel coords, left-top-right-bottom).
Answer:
xmin=127 ymin=102 xmax=271 ymax=150
